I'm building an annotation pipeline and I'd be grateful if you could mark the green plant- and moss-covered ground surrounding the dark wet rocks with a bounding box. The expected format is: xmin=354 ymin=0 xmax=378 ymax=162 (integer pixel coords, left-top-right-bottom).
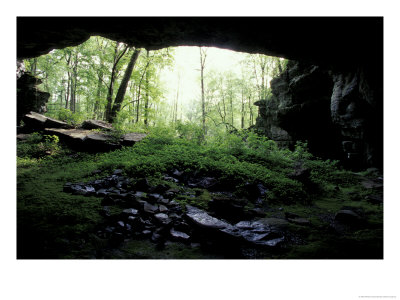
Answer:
xmin=17 ymin=130 xmax=383 ymax=259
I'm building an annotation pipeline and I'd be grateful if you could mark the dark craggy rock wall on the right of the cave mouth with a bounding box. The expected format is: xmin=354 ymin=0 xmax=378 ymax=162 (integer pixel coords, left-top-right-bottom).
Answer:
xmin=256 ymin=61 xmax=383 ymax=168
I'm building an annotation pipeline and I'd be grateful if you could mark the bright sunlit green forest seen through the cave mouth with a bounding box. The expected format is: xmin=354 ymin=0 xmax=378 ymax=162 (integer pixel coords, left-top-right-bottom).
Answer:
xmin=24 ymin=36 xmax=288 ymax=133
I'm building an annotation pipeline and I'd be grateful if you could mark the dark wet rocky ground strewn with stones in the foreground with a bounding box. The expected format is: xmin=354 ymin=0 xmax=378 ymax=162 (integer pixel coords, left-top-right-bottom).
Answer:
xmin=63 ymin=169 xmax=383 ymax=259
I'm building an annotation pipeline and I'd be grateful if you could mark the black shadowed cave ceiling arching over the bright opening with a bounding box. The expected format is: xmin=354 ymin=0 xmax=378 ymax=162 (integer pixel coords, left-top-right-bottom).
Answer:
xmin=17 ymin=17 xmax=383 ymax=68
